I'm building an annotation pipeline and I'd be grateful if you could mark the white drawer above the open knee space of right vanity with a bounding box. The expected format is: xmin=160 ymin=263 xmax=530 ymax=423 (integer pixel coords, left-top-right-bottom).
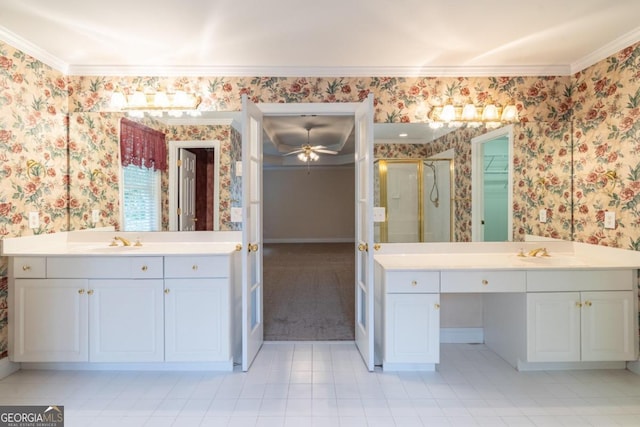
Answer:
xmin=440 ymin=270 xmax=526 ymax=293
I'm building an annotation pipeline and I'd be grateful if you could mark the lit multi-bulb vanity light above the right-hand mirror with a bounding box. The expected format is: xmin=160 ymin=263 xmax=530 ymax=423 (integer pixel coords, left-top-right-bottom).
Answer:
xmin=428 ymin=98 xmax=518 ymax=128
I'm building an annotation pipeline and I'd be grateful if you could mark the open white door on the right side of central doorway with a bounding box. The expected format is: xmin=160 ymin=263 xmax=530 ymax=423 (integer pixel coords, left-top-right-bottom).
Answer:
xmin=355 ymin=94 xmax=374 ymax=371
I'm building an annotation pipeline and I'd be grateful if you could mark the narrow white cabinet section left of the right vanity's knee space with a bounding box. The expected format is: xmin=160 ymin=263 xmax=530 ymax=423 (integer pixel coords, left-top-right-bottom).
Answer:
xmin=376 ymin=269 xmax=440 ymax=370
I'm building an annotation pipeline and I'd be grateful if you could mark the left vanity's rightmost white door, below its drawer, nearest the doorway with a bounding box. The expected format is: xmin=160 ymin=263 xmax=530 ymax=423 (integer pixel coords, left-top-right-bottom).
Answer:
xmin=164 ymin=278 xmax=231 ymax=362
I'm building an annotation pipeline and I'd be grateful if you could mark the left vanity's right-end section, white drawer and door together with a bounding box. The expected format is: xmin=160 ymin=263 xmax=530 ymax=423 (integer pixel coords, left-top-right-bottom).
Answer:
xmin=164 ymin=256 xmax=233 ymax=368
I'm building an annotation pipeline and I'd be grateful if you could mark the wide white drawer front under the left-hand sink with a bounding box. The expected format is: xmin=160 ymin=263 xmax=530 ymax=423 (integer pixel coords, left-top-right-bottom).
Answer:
xmin=47 ymin=256 xmax=162 ymax=279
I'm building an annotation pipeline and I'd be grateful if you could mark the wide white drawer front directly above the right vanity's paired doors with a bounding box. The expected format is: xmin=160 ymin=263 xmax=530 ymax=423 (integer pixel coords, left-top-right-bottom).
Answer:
xmin=527 ymin=269 xmax=635 ymax=292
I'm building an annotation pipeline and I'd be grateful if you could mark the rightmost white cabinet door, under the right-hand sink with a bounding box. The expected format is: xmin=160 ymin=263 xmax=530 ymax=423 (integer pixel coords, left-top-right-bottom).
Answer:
xmin=581 ymin=291 xmax=637 ymax=361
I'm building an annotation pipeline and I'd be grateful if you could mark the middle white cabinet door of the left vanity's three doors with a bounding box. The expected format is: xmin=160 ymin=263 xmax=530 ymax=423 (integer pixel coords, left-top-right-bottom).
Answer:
xmin=88 ymin=279 xmax=164 ymax=362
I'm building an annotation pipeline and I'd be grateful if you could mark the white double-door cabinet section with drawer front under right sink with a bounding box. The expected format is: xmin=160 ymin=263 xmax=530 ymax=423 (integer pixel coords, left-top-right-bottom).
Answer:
xmin=526 ymin=270 xmax=637 ymax=362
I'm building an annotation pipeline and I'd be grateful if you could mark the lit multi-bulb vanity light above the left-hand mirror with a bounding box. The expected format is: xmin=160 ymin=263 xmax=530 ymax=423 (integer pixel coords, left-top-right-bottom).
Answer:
xmin=110 ymin=86 xmax=202 ymax=117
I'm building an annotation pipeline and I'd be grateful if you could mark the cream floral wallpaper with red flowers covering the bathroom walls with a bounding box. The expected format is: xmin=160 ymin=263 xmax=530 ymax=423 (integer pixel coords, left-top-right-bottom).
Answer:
xmin=0 ymin=37 xmax=640 ymax=362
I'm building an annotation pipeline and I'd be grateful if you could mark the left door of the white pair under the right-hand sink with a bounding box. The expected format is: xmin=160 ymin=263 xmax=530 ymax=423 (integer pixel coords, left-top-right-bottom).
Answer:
xmin=527 ymin=292 xmax=581 ymax=362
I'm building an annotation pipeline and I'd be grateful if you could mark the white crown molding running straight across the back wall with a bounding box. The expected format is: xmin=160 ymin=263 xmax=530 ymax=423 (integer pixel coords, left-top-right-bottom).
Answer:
xmin=68 ymin=65 xmax=571 ymax=77
